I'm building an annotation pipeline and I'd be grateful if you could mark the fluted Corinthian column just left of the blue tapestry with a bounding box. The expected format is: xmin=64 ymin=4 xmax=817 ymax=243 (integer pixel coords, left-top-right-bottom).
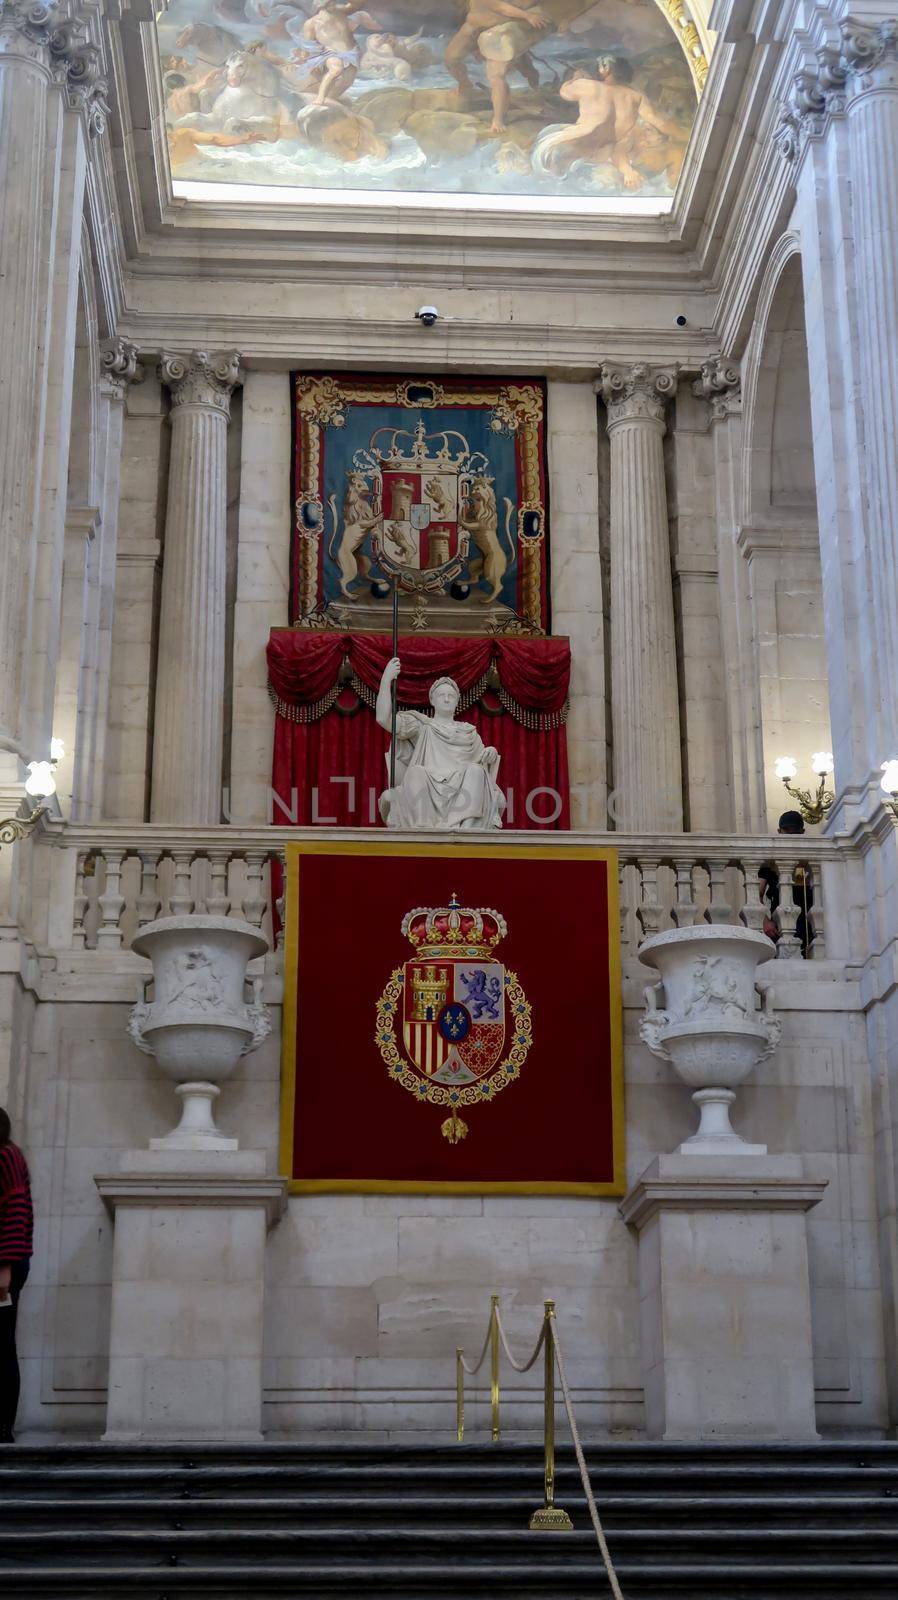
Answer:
xmin=152 ymin=350 xmax=242 ymax=824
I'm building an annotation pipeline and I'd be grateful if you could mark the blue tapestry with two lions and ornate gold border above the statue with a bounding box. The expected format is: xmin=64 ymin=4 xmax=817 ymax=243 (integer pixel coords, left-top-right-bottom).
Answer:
xmin=291 ymin=373 xmax=549 ymax=634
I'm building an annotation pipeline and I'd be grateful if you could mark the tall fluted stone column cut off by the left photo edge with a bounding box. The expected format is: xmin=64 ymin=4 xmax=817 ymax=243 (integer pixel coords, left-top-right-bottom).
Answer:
xmin=0 ymin=8 xmax=50 ymax=749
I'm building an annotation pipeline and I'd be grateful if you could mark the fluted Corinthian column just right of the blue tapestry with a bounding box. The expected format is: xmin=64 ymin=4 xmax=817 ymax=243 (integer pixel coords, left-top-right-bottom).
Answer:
xmin=595 ymin=363 xmax=682 ymax=834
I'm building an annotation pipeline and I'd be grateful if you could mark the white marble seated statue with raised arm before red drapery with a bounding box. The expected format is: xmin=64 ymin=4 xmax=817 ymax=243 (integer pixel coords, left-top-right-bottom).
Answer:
xmin=376 ymin=656 xmax=506 ymax=829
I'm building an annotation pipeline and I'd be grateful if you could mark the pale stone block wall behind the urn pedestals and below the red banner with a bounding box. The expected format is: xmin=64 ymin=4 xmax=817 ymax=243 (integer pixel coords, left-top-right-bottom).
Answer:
xmin=19 ymin=962 xmax=887 ymax=1438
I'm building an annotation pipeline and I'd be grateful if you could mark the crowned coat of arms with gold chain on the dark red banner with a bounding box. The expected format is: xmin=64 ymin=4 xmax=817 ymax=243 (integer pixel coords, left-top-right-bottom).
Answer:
xmin=376 ymin=894 xmax=533 ymax=1144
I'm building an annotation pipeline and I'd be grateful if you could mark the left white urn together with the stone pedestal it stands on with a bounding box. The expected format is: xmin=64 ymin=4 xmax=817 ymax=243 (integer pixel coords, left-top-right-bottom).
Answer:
xmin=96 ymin=917 xmax=287 ymax=1443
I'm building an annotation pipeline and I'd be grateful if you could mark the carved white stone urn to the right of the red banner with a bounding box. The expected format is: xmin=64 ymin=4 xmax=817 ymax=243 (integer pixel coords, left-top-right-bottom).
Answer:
xmin=639 ymin=923 xmax=781 ymax=1155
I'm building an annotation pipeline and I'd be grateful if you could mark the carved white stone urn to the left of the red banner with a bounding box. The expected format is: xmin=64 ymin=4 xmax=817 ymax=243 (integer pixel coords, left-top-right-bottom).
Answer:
xmin=128 ymin=915 xmax=271 ymax=1150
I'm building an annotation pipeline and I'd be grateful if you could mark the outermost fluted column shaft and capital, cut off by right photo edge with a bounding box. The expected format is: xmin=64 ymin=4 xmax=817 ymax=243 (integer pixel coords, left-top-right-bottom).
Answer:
xmin=842 ymin=19 xmax=898 ymax=732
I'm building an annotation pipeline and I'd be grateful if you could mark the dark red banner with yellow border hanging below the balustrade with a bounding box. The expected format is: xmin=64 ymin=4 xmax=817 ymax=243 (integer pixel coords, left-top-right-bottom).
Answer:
xmin=282 ymin=840 xmax=624 ymax=1195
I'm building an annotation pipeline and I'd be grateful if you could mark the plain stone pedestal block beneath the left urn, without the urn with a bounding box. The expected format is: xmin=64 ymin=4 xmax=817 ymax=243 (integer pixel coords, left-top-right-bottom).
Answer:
xmin=96 ymin=1149 xmax=287 ymax=1443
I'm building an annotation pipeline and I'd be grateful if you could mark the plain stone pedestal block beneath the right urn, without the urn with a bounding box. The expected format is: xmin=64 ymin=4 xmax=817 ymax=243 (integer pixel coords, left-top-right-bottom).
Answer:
xmin=621 ymin=1155 xmax=826 ymax=1442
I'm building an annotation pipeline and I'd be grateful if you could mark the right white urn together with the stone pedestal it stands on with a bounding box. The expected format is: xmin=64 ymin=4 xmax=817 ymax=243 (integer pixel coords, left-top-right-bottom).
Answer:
xmin=621 ymin=925 xmax=826 ymax=1442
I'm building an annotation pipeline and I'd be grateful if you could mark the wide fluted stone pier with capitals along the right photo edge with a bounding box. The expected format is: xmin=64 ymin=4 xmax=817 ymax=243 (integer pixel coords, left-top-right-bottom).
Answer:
xmin=776 ymin=16 xmax=898 ymax=812
